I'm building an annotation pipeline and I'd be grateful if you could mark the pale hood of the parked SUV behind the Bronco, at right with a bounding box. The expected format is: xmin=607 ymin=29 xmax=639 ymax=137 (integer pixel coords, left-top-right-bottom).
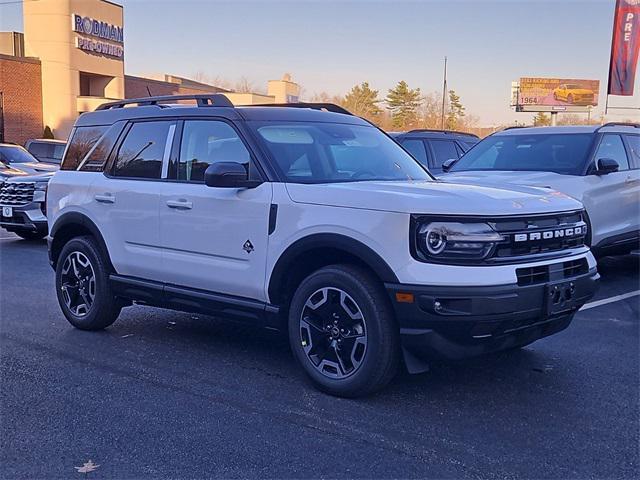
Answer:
xmin=438 ymin=170 xmax=568 ymax=188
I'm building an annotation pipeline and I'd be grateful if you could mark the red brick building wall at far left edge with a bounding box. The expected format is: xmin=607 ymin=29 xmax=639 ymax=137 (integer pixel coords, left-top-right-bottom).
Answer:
xmin=0 ymin=55 xmax=44 ymax=145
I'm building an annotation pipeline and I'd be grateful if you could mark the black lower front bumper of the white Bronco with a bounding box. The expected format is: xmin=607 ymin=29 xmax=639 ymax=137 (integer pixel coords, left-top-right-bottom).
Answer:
xmin=386 ymin=269 xmax=600 ymax=370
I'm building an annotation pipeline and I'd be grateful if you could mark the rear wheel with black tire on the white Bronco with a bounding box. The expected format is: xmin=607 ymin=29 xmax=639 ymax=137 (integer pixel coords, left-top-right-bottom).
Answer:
xmin=56 ymin=236 xmax=122 ymax=330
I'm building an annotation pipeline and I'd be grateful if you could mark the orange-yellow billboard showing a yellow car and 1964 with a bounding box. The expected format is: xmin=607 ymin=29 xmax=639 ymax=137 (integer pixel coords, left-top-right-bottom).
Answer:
xmin=516 ymin=77 xmax=600 ymax=112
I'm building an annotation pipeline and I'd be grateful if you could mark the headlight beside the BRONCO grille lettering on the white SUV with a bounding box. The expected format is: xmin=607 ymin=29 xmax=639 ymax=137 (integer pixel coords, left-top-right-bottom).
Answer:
xmin=416 ymin=222 xmax=505 ymax=261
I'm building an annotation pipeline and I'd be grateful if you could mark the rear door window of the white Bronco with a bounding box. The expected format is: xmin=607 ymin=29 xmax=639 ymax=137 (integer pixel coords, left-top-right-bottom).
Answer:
xmin=112 ymin=121 xmax=175 ymax=179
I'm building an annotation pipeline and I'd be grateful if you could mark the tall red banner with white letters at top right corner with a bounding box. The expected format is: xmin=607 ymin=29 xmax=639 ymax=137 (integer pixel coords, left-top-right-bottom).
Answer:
xmin=607 ymin=0 xmax=640 ymax=95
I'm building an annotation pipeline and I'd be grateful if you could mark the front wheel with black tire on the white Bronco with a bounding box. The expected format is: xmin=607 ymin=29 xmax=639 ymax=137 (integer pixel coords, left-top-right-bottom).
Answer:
xmin=289 ymin=265 xmax=400 ymax=397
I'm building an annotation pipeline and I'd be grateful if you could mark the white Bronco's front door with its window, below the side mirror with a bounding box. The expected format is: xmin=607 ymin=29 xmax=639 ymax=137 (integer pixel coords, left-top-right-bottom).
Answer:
xmin=160 ymin=120 xmax=272 ymax=300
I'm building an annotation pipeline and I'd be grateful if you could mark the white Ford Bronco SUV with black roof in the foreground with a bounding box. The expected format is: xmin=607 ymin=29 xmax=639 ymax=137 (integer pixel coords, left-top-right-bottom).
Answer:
xmin=47 ymin=95 xmax=598 ymax=396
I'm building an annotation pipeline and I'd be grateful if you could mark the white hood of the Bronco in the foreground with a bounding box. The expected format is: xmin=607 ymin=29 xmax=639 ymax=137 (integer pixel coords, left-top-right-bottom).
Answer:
xmin=287 ymin=181 xmax=582 ymax=216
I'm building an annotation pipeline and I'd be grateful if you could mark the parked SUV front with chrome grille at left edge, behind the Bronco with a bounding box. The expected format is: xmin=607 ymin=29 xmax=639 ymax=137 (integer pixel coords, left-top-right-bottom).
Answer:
xmin=0 ymin=172 xmax=54 ymax=240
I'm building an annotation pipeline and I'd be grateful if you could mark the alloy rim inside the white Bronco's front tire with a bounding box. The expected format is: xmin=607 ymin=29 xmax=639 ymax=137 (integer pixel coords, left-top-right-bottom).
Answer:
xmin=300 ymin=287 xmax=367 ymax=379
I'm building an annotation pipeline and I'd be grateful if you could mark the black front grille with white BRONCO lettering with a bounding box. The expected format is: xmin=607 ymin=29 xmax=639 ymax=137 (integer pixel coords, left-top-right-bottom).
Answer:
xmin=491 ymin=212 xmax=587 ymax=262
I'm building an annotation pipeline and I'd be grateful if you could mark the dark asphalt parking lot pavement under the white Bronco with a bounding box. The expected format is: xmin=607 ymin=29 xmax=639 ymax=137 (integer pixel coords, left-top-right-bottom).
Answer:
xmin=0 ymin=232 xmax=640 ymax=478
